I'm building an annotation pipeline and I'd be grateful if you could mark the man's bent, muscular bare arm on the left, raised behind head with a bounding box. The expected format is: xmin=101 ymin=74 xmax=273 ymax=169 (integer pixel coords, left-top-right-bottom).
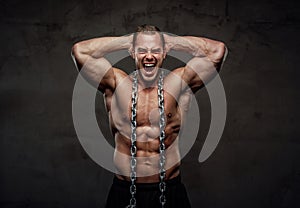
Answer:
xmin=72 ymin=36 xmax=132 ymax=92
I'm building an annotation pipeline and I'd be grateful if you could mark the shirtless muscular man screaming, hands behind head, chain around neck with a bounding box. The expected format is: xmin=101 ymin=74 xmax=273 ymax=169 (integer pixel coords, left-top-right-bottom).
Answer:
xmin=72 ymin=25 xmax=226 ymax=208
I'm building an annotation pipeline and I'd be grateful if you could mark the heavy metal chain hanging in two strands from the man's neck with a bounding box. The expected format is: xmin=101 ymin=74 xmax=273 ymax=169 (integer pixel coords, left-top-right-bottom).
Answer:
xmin=127 ymin=71 xmax=166 ymax=208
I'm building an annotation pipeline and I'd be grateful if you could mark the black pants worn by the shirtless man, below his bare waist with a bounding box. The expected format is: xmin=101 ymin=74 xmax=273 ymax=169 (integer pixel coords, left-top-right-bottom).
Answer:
xmin=105 ymin=176 xmax=191 ymax=208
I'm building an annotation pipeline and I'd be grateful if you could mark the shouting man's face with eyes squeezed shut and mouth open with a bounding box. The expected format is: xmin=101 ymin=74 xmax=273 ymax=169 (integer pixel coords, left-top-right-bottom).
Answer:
xmin=133 ymin=32 xmax=166 ymax=82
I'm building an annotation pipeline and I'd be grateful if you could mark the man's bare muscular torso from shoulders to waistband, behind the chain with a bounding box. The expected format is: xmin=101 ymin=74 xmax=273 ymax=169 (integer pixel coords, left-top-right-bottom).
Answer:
xmin=105 ymin=68 xmax=190 ymax=183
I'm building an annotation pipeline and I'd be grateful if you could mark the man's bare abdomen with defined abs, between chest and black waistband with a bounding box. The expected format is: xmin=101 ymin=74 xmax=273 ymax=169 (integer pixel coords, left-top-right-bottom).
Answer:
xmin=114 ymin=126 xmax=180 ymax=183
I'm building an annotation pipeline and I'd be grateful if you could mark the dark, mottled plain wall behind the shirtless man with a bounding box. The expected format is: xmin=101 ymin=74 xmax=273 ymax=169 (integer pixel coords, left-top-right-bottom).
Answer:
xmin=0 ymin=0 xmax=300 ymax=208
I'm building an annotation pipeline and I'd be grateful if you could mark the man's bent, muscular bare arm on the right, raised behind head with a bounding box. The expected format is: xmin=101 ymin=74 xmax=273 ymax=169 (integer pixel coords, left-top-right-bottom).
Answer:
xmin=164 ymin=34 xmax=227 ymax=92
